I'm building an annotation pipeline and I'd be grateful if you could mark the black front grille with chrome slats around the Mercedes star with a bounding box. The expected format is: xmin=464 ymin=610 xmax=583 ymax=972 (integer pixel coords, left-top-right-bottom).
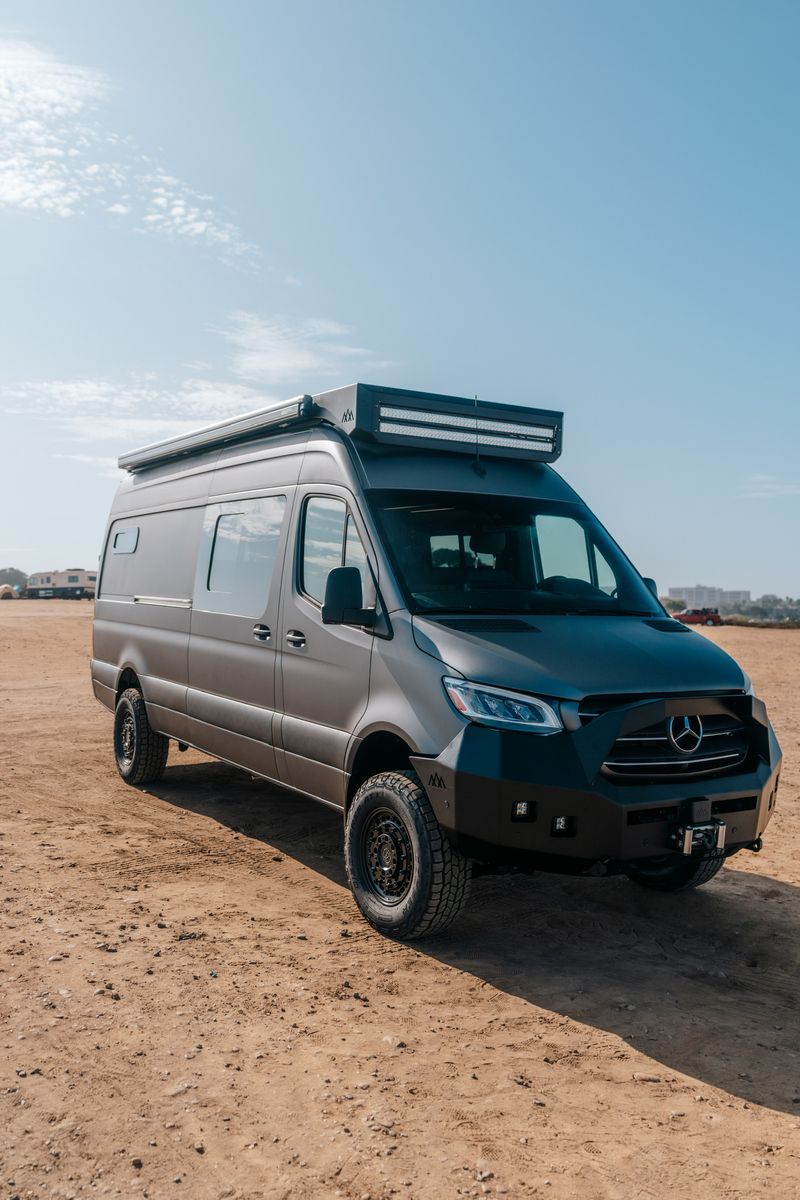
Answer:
xmin=603 ymin=713 xmax=748 ymax=784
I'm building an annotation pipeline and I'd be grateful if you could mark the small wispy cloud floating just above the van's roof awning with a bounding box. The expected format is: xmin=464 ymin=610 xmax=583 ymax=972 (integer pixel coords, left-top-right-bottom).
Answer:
xmin=221 ymin=312 xmax=391 ymax=388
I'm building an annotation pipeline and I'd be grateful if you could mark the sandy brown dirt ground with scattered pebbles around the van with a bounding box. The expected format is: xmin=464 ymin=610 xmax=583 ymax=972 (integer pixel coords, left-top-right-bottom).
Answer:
xmin=0 ymin=601 xmax=800 ymax=1200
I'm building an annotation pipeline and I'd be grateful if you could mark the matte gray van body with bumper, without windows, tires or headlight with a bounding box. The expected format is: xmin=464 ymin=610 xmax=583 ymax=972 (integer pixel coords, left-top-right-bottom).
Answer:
xmin=91 ymin=385 xmax=781 ymax=871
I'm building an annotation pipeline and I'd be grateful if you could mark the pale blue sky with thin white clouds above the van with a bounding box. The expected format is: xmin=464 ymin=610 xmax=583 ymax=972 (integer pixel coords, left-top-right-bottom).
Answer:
xmin=0 ymin=0 xmax=800 ymax=596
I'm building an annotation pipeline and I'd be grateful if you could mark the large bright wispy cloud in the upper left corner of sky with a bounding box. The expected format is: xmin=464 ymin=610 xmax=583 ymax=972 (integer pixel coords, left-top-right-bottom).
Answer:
xmin=0 ymin=38 xmax=258 ymax=264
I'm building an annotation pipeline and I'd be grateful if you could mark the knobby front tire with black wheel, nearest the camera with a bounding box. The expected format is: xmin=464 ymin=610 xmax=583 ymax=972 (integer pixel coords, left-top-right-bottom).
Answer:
xmin=344 ymin=770 xmax=471 ymax=941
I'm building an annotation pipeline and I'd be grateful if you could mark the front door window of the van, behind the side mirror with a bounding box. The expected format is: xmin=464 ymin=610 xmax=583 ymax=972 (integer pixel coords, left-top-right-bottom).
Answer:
xmin=300 ymin=496 xmax=374 ymax=606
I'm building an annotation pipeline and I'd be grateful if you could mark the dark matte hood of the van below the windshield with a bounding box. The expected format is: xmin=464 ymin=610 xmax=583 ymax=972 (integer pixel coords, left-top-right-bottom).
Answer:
xmin=414 ymin=614 xmax=746 ymax=700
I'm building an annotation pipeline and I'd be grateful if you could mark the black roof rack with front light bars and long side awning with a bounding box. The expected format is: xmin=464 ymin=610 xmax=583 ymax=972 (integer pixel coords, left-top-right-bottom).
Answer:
xmin=119 ymin=383 xmax=564 ymax=472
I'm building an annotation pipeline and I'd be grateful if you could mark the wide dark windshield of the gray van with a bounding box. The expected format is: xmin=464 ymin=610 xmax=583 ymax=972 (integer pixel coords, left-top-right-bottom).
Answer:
xmin=367 ymin=490 xmax=663 ymax=617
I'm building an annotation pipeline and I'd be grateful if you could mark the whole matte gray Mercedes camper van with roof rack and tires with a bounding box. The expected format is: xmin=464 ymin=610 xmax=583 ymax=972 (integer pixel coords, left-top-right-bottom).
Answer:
xmin=91 ymin=384 xmax=781 ymax=938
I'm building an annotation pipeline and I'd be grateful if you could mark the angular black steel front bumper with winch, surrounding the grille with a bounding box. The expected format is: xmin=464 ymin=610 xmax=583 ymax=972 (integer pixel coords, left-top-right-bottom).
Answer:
xmin=411 ymin=697 xmax=781 ymax=871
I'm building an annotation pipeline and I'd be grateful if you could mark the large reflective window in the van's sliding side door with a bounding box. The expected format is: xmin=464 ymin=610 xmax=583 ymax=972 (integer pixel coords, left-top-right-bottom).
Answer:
xmin=203 ymin=496 xmax=287 ymax=617
